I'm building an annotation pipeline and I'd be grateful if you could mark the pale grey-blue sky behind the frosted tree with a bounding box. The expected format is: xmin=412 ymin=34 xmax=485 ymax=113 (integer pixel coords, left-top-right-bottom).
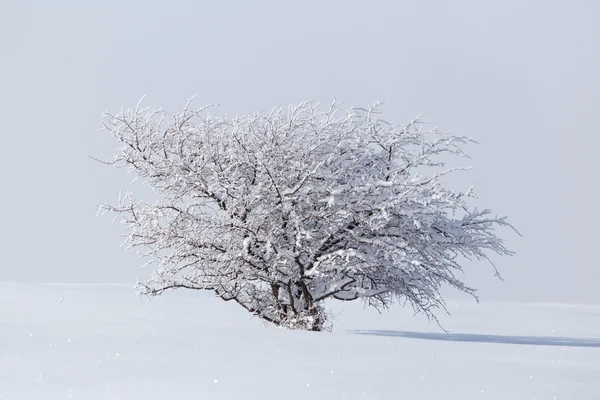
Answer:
xmin=0 ymin=0 xmax=600 ymax=303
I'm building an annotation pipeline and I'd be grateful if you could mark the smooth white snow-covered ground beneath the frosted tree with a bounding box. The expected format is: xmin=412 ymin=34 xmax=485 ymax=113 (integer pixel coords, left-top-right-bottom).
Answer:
xmin=0 ymin=283 xmax=600 ymax=400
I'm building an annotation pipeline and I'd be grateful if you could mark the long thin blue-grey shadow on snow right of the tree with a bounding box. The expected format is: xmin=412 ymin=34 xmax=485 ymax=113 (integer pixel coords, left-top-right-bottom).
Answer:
xmin=350 ymin=330 xmax=600 ymax=347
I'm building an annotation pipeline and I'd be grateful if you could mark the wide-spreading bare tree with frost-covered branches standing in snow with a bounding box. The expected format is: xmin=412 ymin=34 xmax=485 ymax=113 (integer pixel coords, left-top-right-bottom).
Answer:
xmin=98 ymin=96 xmax=512 ymax=331
